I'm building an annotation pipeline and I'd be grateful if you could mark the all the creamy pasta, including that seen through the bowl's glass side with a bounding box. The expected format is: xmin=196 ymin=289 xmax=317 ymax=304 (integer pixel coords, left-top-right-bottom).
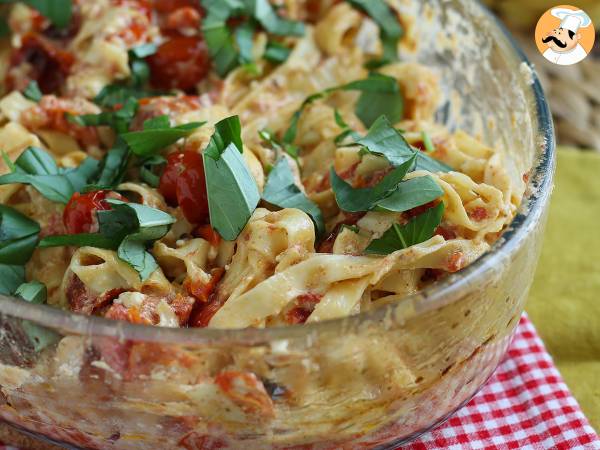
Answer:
xmin=0 ymin=0 xmax=524 ymax=449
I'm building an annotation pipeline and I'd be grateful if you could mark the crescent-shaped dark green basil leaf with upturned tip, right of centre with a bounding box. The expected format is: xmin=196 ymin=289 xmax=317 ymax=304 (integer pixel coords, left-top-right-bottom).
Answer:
xmin=329 ymin=155 xmax=416 ymax=212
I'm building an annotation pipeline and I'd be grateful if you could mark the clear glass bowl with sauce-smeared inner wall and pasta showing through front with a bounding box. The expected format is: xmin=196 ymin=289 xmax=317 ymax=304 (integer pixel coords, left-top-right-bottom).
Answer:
xmin=0 ymin=0 xmax=555 ymax=449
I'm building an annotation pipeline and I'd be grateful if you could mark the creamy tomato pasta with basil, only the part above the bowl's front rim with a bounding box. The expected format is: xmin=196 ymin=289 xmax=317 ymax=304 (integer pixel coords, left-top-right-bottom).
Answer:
xmin=0 ymin=0 xmax=520 ymax=328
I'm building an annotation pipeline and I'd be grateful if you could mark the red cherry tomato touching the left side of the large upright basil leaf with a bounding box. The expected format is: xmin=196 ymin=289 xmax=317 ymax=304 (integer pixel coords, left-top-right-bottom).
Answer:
xmin=158 ymin=151 xmax=208 ymax=223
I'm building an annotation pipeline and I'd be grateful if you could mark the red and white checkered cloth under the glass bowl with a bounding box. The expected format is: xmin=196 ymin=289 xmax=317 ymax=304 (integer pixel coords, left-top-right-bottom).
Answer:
xmin=0 ymin=316 xmax=600 ymax=450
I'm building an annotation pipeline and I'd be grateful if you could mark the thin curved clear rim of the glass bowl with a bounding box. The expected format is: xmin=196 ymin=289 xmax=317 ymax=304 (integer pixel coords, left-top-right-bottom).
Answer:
xmin=0 ymin=3 xmax=555 ymax=345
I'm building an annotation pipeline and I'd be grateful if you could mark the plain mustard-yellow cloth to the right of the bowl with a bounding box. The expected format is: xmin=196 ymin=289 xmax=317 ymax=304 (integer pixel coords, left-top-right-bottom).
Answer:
xmin=526 ymin=148 xmax=600 ymax=431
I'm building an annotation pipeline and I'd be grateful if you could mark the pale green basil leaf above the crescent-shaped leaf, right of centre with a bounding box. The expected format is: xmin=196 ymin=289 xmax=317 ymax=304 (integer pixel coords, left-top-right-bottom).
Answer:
xmin=356 ymin=116 xmax=452 ymax=172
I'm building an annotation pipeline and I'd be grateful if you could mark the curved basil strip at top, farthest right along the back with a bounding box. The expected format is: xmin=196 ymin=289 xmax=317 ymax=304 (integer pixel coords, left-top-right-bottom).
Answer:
xmin=346 ymin=0 xmax=404 ymax=68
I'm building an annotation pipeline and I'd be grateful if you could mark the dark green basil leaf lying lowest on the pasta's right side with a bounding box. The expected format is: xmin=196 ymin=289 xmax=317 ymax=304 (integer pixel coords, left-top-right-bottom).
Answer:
xmin=365 ymin=202 xmax=444 ymax=255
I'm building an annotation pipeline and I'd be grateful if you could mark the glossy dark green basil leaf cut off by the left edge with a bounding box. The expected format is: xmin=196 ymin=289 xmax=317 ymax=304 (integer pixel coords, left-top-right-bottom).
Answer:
xmin=0 ymin=205 xmax=40 ymax=265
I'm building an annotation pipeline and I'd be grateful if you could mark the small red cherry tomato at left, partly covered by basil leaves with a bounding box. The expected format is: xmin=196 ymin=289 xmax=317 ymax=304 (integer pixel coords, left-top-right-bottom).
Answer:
xmin=63 ymin=191 xmax=111 ymax=234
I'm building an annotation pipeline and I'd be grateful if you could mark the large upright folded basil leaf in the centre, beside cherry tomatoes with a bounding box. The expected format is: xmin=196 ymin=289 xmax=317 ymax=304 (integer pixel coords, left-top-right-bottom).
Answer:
xmin=202 ymin=116 xmax=260 ymax=241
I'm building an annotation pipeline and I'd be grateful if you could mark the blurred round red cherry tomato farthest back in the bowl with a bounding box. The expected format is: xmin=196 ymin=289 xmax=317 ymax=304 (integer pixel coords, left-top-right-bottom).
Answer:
xmin=147 ymin=36 xmax=210 ymax=91
